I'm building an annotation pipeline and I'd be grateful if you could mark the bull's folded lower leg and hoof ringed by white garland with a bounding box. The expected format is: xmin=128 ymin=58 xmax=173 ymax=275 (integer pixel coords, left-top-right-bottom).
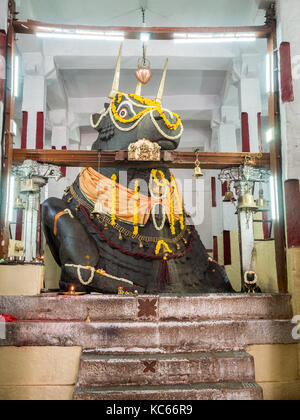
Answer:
xmin=59 ymin=264 xmax=145 ymax=294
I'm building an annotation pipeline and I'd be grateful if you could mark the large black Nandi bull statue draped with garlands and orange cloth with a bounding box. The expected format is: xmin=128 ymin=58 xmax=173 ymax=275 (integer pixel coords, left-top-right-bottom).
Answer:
xmin=43 ymin=46 xmax=233 ymax=295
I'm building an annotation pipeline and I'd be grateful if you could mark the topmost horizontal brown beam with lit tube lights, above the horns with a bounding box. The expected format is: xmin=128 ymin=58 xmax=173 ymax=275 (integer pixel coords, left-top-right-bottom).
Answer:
xmin=14 ymin=20 xmax=272 ymax=40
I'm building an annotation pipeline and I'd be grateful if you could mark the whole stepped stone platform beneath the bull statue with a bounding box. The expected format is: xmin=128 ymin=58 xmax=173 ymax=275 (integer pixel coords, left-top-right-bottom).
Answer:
xmin=0 ymin=294 xmax=295 ymax=400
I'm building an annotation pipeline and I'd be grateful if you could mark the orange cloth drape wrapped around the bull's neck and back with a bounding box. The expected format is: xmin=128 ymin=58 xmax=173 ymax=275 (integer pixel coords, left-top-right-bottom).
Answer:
xmin=79 ymin=168 xmax=183 ymax=226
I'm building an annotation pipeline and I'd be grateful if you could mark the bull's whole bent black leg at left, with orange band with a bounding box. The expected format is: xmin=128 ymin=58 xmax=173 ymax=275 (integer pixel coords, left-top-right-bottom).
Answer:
xmin=43 ymin=198 xmax=142 ymax=293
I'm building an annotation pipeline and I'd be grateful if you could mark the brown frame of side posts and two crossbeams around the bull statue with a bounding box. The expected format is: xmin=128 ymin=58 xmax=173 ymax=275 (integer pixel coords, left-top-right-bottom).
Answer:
xmin=0 ymin=0 xmax=288 ymax=292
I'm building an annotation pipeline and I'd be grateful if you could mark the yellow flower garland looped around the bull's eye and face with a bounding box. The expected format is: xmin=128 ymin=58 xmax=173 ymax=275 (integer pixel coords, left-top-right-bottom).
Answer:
xmin=111 ymin=92 xmax=181 ymax=131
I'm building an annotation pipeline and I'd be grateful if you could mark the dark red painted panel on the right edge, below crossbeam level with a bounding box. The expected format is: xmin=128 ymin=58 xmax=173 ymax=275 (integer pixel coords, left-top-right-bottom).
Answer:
xmin=284 ymin=179 xmax=300 ymax=248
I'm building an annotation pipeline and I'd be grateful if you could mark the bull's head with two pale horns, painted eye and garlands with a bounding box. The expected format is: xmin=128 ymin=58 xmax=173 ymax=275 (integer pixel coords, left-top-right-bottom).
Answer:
xmin=91 ymin=46 xmax=183 ymax=150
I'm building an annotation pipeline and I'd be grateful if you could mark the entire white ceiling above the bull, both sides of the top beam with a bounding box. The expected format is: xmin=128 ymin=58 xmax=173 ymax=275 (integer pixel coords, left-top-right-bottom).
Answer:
xmin=16 ymin=0 xmax=268 ymax=148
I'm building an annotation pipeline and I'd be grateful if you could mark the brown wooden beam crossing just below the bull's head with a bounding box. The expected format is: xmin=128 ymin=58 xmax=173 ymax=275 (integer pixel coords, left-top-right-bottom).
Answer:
xmin=13 ymin=149 xmax=270 ymax=169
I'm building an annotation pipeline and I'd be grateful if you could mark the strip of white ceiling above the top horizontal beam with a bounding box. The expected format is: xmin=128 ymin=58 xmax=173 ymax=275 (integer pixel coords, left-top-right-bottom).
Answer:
xmin=17 ymin=0 xmax=264 ymax=26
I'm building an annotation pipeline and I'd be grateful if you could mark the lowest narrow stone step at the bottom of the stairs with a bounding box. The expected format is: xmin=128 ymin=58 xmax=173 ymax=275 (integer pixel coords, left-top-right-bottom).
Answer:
xmin=74 ymin=382 xmax=263 ymax=405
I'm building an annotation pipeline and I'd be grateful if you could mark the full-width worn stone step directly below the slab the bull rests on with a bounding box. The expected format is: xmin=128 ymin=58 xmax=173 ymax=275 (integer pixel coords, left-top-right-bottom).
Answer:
xmin=0 ymin=320 xmax=298 ymax=354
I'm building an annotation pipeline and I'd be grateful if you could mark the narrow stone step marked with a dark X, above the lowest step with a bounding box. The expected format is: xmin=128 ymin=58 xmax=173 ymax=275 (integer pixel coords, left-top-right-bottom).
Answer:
xmin=78 ymin=352 xmax=255 ymax=387
